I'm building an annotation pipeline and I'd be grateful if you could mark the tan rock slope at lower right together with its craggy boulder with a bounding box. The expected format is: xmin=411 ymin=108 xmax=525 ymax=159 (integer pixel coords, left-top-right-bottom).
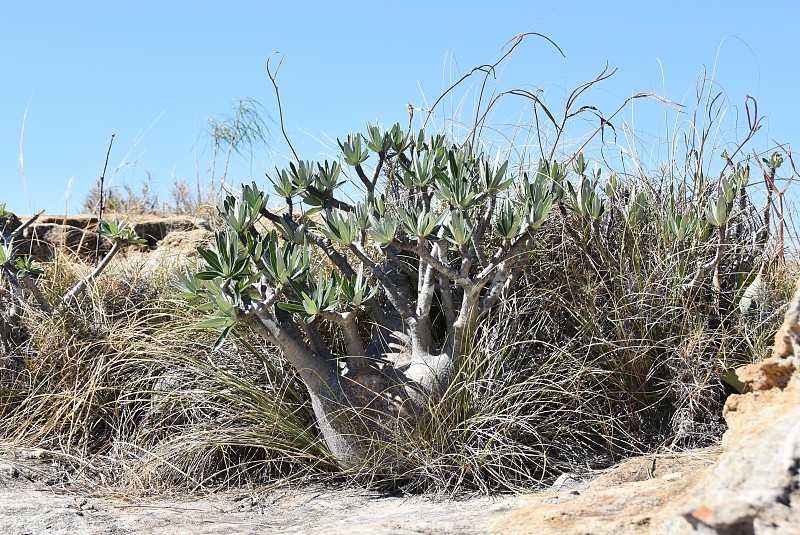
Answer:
xmin=490 ymin=285 xmax=800 ymax=535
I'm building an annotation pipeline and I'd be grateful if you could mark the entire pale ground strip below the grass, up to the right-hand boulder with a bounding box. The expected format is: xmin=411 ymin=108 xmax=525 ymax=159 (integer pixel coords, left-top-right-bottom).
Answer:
xmin=0 ymin=447 xmax=719 ymax=535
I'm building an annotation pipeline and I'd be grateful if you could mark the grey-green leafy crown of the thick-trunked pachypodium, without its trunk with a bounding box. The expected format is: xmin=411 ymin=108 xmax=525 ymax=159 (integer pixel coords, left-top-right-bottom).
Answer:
xmin=174 ymin=125 xmax=565 ymax=358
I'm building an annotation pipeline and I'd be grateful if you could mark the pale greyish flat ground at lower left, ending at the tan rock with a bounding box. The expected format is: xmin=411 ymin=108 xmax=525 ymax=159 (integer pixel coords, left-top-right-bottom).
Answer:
xmin=0 ymin=452 xmax=536 ymax=535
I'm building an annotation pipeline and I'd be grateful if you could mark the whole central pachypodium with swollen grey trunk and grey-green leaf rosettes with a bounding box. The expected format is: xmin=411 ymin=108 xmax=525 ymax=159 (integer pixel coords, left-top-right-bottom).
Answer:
xmin=178 ymin=125 xmax=566 ymax=466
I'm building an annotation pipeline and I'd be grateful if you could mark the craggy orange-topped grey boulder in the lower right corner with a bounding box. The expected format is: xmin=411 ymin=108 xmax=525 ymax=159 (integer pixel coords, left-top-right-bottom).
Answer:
xmin=685 ymin=364 xmax=800 ymax=535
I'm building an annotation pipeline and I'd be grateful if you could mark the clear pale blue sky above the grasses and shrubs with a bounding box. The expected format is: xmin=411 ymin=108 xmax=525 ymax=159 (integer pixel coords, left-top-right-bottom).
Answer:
xmin=0 ymin=0 xmax=800 ymax=213
